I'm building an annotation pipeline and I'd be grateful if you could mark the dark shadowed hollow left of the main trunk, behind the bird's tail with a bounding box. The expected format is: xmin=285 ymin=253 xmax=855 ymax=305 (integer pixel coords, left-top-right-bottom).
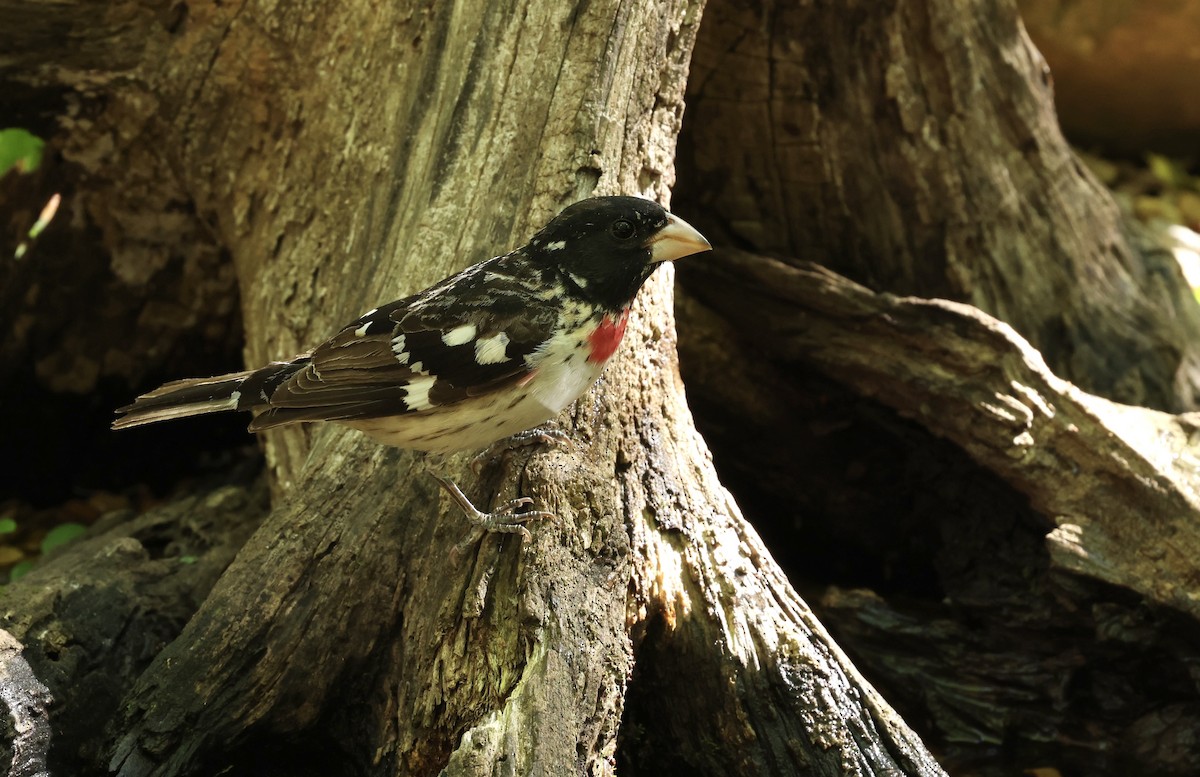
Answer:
xmin=0 ymin=151 xmax=248 ymax=510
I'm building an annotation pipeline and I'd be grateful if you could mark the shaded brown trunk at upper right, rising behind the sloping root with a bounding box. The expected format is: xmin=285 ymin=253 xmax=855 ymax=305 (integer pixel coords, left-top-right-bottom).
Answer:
xmin=678 ymin=0 xmax=1200 ymax=411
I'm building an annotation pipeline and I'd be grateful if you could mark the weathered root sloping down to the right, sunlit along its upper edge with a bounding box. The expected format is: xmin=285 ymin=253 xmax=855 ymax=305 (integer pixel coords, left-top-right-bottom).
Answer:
xmin=700 ymin=251 xmax=1200 ymax=618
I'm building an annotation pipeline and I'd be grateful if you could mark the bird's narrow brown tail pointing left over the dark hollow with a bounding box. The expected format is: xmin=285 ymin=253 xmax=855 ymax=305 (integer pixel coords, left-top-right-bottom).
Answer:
xmin=113 ymin=359 xmax=307 ymax=429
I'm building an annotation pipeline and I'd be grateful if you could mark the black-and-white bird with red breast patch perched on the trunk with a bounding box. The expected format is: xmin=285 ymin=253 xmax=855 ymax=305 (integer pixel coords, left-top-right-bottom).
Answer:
xmin=113 ymin=195 xmax=712 ymax=538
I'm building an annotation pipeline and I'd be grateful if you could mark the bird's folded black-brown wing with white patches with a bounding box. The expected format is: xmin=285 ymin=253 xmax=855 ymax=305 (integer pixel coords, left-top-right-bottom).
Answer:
xmin=251 ymin=254 xmax=557 ymax=429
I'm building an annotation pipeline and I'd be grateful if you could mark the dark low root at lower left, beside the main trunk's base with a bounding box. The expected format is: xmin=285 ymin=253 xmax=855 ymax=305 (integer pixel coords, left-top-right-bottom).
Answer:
xmin=2 ymin=468 xmax=268 ymax=775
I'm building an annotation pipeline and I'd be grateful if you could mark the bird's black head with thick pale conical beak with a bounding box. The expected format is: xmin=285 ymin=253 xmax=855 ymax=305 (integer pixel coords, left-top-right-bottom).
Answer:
xmin=529 ymin=197 xmax=712 ymax=309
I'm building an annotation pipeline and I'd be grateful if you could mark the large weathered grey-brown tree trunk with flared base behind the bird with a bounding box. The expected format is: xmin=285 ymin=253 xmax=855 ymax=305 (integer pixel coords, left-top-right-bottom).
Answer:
xmin=0 ymin=0 xmax=941 ymax=776
